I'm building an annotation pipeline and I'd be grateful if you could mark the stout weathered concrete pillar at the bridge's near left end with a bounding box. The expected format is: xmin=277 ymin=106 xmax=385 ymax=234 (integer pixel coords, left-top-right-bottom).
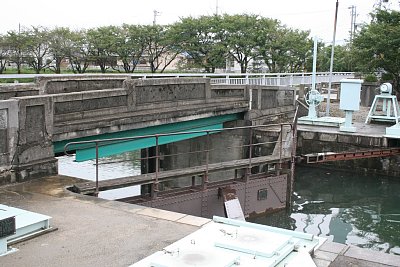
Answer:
xmin=0 ymin=96 xmax=57 ymax=182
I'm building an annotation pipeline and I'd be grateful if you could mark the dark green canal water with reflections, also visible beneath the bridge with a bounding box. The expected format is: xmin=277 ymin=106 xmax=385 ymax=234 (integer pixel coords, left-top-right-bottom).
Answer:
xmin=58 ymin=152 xmax=400 ymax=254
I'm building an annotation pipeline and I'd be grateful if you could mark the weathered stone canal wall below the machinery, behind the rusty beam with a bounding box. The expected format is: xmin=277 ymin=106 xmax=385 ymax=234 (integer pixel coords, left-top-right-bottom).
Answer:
xmin=297 ymin=122 xmax=400 ymax=177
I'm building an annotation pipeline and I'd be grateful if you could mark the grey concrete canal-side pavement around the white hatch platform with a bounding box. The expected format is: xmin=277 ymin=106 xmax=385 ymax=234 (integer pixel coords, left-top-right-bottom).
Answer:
xmin=0 ymin=175 xmax=400 ymax=267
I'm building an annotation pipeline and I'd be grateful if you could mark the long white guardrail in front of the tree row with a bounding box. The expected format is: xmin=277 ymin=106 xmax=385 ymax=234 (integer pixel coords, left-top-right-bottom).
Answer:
xmin=0 ymin=72 xmax=354 ymax=86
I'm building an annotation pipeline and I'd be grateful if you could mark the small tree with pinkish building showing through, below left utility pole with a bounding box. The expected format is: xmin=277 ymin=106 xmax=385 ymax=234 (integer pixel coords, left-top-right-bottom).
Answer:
xmin=144 ymin=25 xmax=181 ymax=73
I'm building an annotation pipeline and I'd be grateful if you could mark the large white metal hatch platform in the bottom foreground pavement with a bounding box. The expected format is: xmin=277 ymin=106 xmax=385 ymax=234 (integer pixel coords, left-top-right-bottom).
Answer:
xmin=131 ymin=216 xmax=326 ymax=267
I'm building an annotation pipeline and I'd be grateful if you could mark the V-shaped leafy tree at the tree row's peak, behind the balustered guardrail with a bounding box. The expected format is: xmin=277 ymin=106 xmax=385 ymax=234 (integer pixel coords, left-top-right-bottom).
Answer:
xmin=216 ymin=14 xmax=262 ymax=73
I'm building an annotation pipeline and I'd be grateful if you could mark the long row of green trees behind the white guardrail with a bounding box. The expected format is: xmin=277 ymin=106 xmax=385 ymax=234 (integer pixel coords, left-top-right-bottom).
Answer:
xmin=0 ymin=14 xmax=360 ymax=76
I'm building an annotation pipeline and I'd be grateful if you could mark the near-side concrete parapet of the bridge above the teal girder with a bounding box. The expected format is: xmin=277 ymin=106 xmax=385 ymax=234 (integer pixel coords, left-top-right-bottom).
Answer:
xmin=52 ymin=78 xmax=248 ymax=141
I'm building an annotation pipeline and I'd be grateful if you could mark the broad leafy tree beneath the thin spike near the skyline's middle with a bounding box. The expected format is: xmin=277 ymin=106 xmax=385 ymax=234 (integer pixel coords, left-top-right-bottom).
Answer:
xmin=170 ymin=16 xmax=226 ymax=73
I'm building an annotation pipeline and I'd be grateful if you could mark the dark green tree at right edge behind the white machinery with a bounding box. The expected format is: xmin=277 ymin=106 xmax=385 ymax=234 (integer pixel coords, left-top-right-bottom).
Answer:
xmin=353 ymin=10 xmax=400 ymax=96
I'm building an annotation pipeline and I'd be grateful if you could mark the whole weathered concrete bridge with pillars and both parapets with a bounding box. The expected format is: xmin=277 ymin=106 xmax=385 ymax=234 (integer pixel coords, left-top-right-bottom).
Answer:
xmin=0 ymin=75 xmax=294 ymax=184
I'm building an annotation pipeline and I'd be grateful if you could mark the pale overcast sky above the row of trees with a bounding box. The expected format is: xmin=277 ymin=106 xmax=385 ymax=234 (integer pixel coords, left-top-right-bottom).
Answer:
xmin=0 ymin=0 xmax=398 ymax=43
